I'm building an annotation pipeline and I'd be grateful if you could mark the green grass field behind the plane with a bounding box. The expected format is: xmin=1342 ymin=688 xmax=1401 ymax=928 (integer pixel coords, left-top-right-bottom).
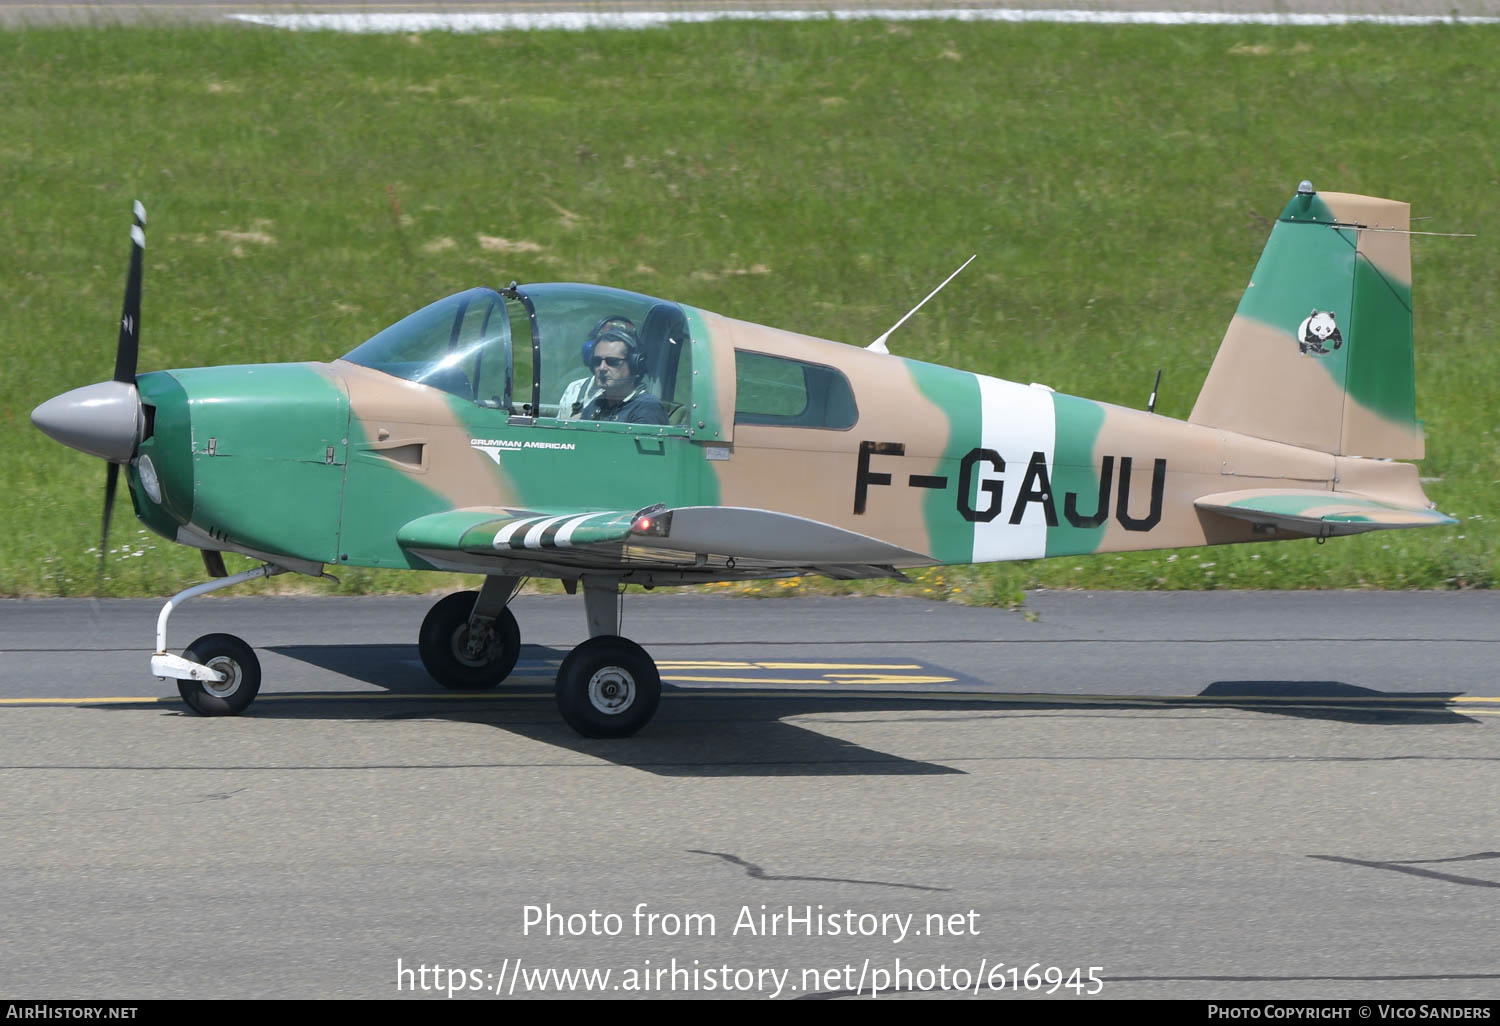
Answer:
xmin=0 ymin=21 xmax=1500 ymax=602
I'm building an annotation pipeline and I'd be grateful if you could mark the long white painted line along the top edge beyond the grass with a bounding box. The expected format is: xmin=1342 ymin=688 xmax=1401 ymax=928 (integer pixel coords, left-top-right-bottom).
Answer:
xmin=230 ymin=8 xmax=1500 ymax=33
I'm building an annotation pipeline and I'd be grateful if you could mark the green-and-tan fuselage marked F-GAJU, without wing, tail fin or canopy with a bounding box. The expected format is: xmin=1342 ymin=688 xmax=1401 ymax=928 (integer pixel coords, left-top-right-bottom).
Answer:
xmin=117 ymin=288 xmax=1421 ymax=569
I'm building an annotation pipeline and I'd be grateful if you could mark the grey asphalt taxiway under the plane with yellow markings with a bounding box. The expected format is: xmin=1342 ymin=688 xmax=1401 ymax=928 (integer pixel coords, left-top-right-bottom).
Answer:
xmin=0 ymin=593 xmax=1500 ymax=1001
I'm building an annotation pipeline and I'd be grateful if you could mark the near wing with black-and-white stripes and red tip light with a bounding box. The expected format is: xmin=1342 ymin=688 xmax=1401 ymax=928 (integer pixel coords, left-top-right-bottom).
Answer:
xmin=396 ymin=506 xmax=935 ymax=582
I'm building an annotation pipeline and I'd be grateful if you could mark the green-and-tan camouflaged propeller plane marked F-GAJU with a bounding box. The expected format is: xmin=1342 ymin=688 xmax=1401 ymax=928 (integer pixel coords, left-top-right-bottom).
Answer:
xmin=32 ymin=182 xmax=1455 ymax=738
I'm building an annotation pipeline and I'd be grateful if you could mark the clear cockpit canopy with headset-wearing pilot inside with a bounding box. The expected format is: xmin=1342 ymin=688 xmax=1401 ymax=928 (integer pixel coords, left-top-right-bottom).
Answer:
xmin=344 ymin=285 xmax=692 ymax=425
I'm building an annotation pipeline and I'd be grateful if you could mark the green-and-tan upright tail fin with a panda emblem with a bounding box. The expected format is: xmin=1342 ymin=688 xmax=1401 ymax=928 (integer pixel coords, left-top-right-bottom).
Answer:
xmin=1188 ymin=182 xmax=1424 ymax=459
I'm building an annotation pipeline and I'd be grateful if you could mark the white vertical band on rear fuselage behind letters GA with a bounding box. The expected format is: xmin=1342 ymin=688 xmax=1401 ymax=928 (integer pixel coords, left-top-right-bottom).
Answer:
xmin=972 ymin=375 xmax=1058 ymax=563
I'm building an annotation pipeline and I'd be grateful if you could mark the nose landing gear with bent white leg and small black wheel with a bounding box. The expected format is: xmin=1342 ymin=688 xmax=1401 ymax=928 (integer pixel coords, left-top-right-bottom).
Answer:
xmin=152 ymin=564 xmax=287 ymax=716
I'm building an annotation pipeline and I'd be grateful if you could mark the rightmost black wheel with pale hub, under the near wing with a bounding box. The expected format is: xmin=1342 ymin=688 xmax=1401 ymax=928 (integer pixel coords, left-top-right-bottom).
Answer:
xmin=557 ymin=635 xmax=662 ymax=738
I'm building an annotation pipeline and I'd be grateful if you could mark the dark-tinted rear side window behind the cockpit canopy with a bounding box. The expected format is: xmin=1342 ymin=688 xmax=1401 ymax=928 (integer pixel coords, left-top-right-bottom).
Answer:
xmin=735 ymin=350 xmax=860 ymax=431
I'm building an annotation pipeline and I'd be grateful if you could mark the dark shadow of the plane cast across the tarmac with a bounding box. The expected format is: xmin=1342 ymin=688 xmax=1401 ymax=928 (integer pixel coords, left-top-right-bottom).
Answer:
xmin=132 ymin=645 xmax=1476 ymax=777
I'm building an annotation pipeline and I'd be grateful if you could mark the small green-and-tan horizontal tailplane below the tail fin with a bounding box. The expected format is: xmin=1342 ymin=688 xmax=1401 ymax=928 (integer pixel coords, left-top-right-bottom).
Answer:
xmin=1193 ymin=488 xmax=1458 ymax=537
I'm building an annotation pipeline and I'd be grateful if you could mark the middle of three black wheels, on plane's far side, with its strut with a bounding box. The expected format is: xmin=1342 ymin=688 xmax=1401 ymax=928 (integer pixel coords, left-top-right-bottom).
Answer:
xmin=417 ymin=576 xmax=522 ymax=692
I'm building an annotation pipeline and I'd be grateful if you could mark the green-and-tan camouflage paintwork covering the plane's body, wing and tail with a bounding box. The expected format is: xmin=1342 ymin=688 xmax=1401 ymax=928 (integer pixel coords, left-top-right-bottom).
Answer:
xmin=129 ymin=185 xmax=1452 ymax=584
